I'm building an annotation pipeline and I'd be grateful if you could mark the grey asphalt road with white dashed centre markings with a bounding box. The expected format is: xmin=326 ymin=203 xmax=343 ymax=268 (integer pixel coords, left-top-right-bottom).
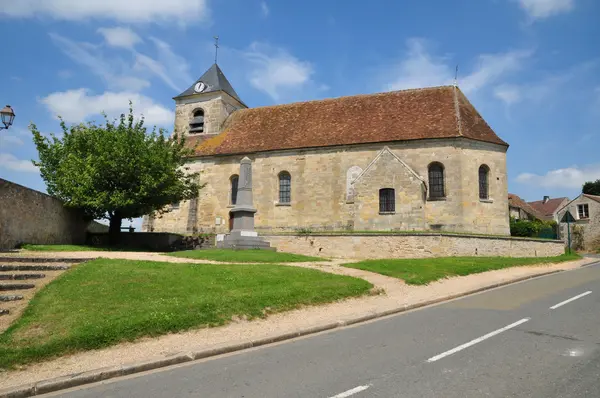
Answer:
xmin=53 ymin=265 xmax=600 ymax=398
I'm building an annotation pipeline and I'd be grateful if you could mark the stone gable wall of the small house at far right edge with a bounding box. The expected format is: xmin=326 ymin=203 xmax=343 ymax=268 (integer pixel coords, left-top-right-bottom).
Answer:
xmin=558 ymin=195 xmax=600 ymax=250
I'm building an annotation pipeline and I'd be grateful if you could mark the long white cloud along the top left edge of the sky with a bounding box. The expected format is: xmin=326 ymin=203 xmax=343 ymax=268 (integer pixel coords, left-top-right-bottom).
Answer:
xmin=0 ymin=0 xmax=208 ymax=23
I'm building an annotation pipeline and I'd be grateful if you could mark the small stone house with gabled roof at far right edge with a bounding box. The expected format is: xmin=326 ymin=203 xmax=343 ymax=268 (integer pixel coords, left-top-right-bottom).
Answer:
xmin=558 ymin=193 xmax=600 ymax=250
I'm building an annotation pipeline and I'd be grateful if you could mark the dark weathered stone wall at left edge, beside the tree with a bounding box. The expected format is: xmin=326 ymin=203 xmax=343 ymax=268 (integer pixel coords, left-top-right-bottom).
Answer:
xmin=0 ymin=178 xmax=88 ymax=250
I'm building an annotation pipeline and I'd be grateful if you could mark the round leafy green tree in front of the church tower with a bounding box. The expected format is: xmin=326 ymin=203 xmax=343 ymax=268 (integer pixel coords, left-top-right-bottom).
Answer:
xmin=29 ymin=103 xmax=201 ymax=244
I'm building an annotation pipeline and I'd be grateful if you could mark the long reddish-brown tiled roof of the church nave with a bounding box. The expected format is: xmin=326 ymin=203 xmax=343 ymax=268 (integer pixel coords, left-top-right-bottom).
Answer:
xmin=188 ymin=86 xmax=508 ymax=156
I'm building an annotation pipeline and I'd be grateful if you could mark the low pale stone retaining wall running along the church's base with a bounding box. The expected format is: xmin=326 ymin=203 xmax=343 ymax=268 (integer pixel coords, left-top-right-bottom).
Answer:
xmin=264 ymin=234 xmax=564 ymax=259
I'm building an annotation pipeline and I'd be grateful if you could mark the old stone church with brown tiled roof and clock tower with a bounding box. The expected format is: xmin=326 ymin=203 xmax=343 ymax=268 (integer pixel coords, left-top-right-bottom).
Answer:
xmin=143 ymin=64 xmax=509 ymax=235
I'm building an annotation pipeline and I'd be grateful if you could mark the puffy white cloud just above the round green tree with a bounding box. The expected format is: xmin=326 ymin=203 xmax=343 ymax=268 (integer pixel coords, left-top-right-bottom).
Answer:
xmin=40 ymin=88 xmax=175 ymax=126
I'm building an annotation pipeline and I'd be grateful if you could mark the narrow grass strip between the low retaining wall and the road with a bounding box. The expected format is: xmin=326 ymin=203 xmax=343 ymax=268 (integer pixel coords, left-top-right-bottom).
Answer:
xmin=344 ymin=254 xmax=581 ymax=285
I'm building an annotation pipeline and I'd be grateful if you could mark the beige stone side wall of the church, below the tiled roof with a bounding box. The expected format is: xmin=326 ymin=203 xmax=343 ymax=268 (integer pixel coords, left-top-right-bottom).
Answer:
xmin=151 ymin=139 xmax=509 ymax=235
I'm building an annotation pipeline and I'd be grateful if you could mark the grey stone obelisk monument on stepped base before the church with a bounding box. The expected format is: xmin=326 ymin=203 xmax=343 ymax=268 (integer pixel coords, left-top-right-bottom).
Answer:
xmin=217 ymin=157 xmax=271 ymax=250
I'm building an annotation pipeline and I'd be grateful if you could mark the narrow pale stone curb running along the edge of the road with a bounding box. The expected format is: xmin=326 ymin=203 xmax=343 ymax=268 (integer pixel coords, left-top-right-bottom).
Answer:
xmin=0 ymin=263 xmax=576 ymax=398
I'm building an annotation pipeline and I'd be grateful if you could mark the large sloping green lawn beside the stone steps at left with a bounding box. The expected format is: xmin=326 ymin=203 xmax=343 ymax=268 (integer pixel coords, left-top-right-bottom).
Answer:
xmin=0 ymin=259 xmax=372 ymax=368
